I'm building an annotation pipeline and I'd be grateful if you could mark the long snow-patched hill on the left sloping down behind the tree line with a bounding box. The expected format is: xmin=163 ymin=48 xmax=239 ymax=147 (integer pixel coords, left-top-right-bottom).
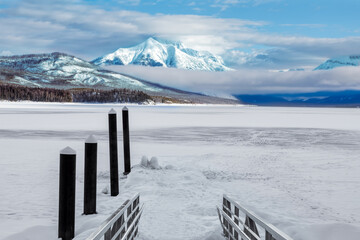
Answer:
xmin=0 ymin=52 xmax=236 ymax=103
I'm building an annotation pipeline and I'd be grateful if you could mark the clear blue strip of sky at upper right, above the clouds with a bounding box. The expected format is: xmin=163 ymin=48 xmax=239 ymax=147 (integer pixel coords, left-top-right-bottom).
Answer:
xmin=105 ymin=0 xmax=360 ymax=37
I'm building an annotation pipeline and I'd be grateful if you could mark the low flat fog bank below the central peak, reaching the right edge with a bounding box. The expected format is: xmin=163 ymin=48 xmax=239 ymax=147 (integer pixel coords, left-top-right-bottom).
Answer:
xmin=107 ymin=66 xmax=360 ymax=94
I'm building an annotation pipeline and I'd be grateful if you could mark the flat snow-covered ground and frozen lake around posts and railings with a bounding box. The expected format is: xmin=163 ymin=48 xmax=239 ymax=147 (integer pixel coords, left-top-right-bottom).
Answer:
xmin=0 ymin=102 xmax=360 ymax=240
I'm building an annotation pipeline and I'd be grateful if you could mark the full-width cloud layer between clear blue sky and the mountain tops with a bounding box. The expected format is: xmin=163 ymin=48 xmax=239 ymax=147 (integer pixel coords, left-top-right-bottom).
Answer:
xmin=0 ymin=0 xmax=360 ymax=69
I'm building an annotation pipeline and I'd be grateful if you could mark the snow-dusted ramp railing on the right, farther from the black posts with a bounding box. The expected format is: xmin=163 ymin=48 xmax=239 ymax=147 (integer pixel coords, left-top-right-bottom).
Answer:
xmin=217 ymin=195 xmax=292 ymax=240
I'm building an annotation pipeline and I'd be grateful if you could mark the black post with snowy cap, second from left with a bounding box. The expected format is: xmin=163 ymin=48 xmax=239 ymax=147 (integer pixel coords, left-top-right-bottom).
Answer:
xmin=84 ymin=135 xmax=97 ymax=214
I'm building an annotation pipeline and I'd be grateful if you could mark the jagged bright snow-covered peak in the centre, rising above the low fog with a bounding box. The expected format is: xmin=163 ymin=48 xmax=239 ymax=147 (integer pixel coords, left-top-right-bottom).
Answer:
xmin=92 ymin=38 xmax=231 ymax=71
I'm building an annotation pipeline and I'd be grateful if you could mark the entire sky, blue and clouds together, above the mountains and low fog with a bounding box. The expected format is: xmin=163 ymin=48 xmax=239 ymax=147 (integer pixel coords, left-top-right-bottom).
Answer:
xmin=0 ymin=0 xmax=360 ymax=69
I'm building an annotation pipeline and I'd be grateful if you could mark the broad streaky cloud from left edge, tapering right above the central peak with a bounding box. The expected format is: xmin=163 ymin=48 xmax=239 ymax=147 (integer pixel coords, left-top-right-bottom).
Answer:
xmin=0 ymin=2 xmax=265 ymax=57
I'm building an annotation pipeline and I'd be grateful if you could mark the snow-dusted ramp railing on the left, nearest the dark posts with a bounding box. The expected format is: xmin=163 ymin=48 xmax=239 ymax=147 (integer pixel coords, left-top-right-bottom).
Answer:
xmin=86 ymin=194 xmax=144 ymax=240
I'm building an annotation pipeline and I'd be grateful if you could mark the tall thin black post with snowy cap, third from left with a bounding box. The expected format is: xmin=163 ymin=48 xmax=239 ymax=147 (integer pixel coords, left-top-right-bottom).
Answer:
xmin=109 ymin=108 xmax=119 ymax=196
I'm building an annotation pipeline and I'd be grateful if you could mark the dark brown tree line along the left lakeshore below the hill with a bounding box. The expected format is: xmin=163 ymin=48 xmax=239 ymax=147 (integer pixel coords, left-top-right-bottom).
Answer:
xmin=0 ymin=83 xmax=151 ymax=103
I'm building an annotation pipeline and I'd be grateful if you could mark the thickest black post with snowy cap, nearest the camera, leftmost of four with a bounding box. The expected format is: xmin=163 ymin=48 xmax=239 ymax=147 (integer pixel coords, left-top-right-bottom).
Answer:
xmin=58 ymin=147 xmax=76 ymax=240
